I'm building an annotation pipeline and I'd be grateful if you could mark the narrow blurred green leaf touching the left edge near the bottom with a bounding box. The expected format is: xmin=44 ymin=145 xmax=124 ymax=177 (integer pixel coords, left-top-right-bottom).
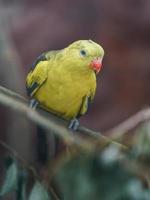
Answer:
xmin=0 ymin=161 xmax=18 ymax=196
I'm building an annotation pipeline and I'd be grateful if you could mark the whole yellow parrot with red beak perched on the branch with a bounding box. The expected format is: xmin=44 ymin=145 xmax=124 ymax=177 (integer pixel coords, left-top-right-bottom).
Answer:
xmin=26 ymin=40 xmax=104 ymax=130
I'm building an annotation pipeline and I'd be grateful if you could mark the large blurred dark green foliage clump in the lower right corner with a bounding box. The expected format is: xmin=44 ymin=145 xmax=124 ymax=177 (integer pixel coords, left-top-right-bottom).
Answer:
xmin=56 ymin=152 xmax=150 ymax=200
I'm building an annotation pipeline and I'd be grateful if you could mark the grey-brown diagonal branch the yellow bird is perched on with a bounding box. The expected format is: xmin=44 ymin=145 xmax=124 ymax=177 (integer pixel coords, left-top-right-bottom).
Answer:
xmin=0 ymin=86 xmax=126 ymax=150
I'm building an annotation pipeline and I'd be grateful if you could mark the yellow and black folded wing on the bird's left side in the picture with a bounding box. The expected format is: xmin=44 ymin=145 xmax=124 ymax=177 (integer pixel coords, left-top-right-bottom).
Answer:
xmin=26 ymin=50 xmax=59 ymax=97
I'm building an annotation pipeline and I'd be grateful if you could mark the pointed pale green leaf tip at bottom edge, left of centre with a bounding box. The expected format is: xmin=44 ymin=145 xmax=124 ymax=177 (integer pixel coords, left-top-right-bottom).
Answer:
xmin=29 ymin=181 xmax=50 ymax=200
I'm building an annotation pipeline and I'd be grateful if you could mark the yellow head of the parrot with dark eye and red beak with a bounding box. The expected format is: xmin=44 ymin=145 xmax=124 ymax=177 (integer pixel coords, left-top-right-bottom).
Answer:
xmin=66 ymin=40 xmax=104 ymax=74
